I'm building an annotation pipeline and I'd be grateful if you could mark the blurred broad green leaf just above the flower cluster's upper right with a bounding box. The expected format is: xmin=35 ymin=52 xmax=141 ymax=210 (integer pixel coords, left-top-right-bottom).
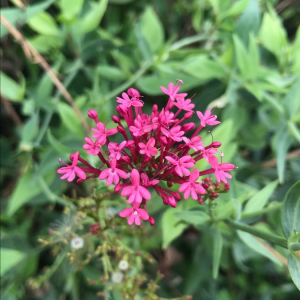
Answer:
xmin=182 ymin=54 xmax=227 ymax=82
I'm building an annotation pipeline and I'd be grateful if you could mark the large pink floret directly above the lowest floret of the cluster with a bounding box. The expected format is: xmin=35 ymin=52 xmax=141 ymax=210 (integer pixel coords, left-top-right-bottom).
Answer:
xmin=121 ymin=169 xmax=151 ymax=205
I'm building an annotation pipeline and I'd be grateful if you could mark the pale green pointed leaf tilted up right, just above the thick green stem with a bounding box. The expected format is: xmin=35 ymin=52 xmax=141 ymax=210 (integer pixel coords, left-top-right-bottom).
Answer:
xmin=243 ymin=180 xmax=278 ymax=213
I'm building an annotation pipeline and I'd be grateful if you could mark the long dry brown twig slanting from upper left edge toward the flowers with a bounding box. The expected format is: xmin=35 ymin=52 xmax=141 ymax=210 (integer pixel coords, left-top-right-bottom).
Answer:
xmin=0 ymin=14 xmax=90 ymax=132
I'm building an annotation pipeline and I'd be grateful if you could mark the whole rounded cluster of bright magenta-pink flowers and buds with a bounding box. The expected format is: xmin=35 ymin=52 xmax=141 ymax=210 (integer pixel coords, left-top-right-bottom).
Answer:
xmin=57 ymin=80 xmax=235 ymax=225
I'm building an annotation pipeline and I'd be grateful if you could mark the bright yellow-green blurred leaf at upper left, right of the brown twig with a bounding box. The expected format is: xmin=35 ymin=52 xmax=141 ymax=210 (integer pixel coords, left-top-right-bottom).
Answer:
xmin=28 ymin=12 xmax=60 ymax=38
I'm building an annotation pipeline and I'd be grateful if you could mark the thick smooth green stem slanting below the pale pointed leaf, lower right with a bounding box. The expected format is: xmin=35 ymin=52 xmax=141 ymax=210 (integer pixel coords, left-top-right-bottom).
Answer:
xmin=226 ymin=219 xmax=288 ymax=249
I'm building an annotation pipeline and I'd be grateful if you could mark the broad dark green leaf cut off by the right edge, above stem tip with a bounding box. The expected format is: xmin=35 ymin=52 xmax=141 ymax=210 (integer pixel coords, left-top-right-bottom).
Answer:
xmin=281 ymin=180 xmax=300 ymax=238
